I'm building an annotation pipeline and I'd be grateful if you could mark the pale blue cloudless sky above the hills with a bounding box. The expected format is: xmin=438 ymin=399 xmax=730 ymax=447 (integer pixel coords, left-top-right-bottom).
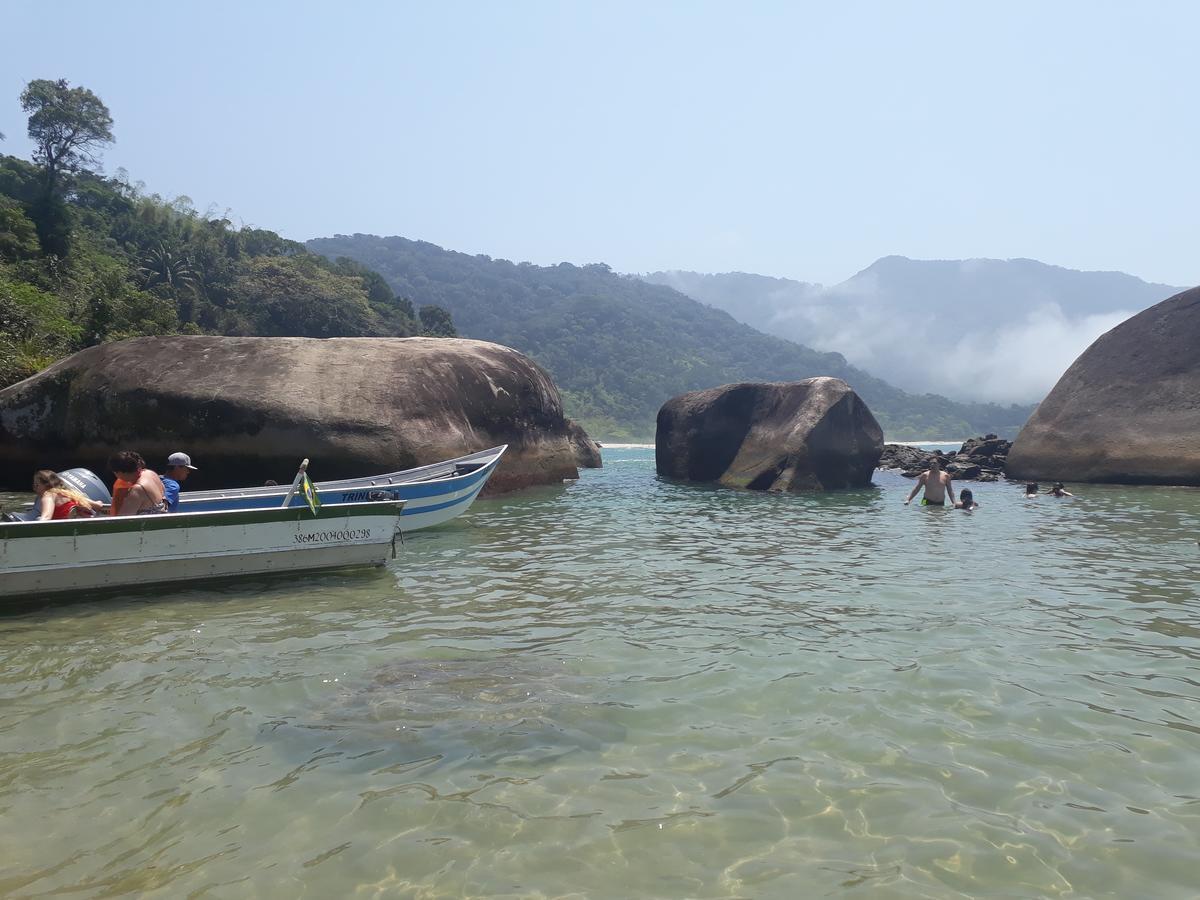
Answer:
xmin=0 ymin=0 xmax=1200 ymax=284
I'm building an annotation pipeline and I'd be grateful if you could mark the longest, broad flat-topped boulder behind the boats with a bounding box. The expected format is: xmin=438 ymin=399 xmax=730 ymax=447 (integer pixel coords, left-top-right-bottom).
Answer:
xmin=0 ymin=336 xmax=600 ymax=491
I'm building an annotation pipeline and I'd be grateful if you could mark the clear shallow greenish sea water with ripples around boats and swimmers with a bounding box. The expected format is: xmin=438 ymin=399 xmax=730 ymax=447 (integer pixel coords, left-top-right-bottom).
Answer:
xmin=0 ymin=450 xmax=1200 ymax=898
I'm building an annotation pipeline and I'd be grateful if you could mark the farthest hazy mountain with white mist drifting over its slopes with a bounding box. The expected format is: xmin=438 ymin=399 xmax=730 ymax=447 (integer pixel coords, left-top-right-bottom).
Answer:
xmin=641 ymin=256 xmax=1182 ymax=403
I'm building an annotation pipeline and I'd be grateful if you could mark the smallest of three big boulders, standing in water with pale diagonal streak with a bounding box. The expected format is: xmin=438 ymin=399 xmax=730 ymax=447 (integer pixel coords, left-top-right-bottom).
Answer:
xmin=654 ymin=378 xmax=883 ymax=491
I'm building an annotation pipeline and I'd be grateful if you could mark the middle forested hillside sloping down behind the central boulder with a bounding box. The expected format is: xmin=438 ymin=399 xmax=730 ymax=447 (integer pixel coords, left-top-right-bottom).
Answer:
xmin=308 ymin=234 xmax=1031 ymax=440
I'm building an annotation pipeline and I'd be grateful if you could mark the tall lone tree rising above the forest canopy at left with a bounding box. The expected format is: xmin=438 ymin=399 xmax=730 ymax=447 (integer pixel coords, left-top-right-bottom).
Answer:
xmin=20 ymin=78 xmax=113 ymax=256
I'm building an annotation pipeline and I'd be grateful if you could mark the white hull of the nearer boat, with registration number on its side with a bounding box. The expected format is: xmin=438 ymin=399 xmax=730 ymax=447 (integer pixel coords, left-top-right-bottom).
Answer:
xmin=0 ymin=502 xmax=403 ymax=599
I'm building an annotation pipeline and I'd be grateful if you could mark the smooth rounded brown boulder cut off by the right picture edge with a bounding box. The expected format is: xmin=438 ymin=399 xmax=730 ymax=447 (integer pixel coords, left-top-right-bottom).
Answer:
xmin=1007 ymin=288 xmax=1200 ymax=485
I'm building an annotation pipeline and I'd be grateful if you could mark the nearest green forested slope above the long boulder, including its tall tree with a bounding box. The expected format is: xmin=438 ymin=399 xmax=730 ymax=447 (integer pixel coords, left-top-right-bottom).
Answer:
xmin=0 ymin=80 xmax=455 ymax=388
